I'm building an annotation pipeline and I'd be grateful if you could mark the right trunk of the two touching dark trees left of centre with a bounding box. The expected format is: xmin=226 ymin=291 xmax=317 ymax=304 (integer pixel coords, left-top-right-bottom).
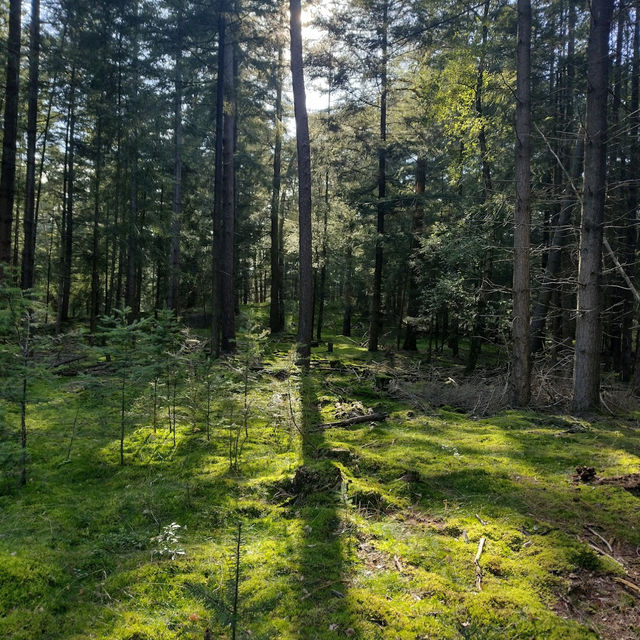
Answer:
xmin=220 ymin=15 xmax=237 ymax=353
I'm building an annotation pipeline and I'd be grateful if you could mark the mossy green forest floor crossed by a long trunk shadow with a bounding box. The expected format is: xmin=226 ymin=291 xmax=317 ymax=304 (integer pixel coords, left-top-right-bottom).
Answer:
xmin=0 ymin=320 xmax=640 ymax=640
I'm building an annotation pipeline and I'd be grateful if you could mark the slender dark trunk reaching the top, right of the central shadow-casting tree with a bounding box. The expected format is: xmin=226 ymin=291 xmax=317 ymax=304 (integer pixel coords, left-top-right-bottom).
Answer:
xmin=368 ymin=0 xmax=389 ymax=351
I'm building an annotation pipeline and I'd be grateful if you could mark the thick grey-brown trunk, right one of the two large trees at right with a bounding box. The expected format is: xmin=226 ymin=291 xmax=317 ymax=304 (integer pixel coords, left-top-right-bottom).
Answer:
xmin=573 ymin=0 xmax=613 ymax=412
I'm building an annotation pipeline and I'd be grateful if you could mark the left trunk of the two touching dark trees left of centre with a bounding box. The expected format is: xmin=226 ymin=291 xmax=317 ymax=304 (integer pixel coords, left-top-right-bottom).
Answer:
xmin=211 ymin=0 xmax=227 ymax=356
